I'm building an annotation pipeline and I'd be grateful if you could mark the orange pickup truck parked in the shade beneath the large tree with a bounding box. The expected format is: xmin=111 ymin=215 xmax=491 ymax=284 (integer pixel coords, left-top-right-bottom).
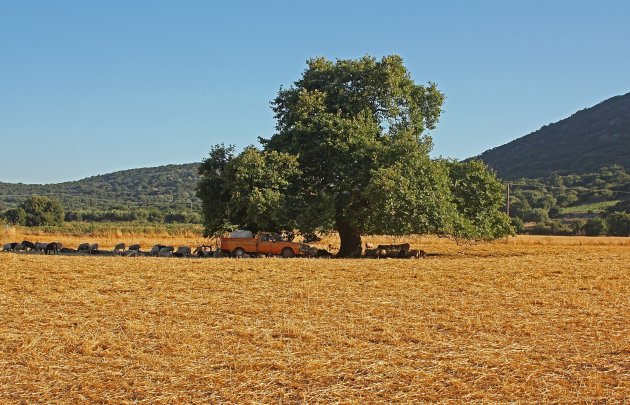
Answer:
xmin=220 ymin=232 xmax=309 ymax=257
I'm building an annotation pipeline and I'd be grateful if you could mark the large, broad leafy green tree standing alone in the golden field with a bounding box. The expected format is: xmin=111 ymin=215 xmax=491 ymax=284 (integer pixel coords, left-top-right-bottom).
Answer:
xmin=197 ymin=55 xmax=511 ymax=256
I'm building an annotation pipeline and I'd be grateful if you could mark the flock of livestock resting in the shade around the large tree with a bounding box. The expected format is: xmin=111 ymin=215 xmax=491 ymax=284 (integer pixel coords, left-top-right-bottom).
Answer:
xmin=2 ymin=240 xmax=426 ymax=259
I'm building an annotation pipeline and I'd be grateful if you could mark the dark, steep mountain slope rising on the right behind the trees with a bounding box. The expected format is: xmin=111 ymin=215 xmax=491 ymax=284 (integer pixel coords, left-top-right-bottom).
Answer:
xmin=475 ymin=93 xmax=630 ymax=180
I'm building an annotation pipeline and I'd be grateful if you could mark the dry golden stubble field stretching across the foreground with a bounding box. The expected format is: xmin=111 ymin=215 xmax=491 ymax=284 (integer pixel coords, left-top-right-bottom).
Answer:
xmin=0 ymin=232 xmax=630 ymax=403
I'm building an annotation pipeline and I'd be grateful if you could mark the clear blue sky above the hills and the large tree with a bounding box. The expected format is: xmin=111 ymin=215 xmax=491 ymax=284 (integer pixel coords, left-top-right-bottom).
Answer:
xmin=0 ymin=0 xmax=630 ymax=183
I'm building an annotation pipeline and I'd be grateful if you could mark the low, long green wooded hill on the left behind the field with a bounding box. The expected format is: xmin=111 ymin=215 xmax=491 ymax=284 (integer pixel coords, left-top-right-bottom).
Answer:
xmin=0 ymin=163 xmax=199 ymax=210
